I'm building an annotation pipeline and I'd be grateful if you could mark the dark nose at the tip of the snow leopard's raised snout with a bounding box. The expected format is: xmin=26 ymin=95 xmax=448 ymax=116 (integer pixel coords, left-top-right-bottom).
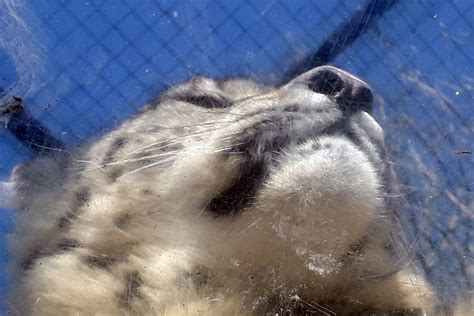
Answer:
xmin=309 ymin=66 xmax=374 ymax=110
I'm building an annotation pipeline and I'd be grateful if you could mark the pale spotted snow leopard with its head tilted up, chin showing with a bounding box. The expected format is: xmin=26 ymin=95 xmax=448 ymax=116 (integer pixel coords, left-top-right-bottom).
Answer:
xmin=9 ymin=66 xmax=434 ymax=315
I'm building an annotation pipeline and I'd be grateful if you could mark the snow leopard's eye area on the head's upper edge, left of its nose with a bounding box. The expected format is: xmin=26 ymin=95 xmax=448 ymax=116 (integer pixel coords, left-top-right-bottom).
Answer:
xmin=163 ymin=77 xmax=232 ymax=109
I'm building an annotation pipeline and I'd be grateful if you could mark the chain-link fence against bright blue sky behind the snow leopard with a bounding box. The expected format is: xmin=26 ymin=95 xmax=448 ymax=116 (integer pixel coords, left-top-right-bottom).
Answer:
xmin=0 ymin=0 xmax=474 ymax=312
